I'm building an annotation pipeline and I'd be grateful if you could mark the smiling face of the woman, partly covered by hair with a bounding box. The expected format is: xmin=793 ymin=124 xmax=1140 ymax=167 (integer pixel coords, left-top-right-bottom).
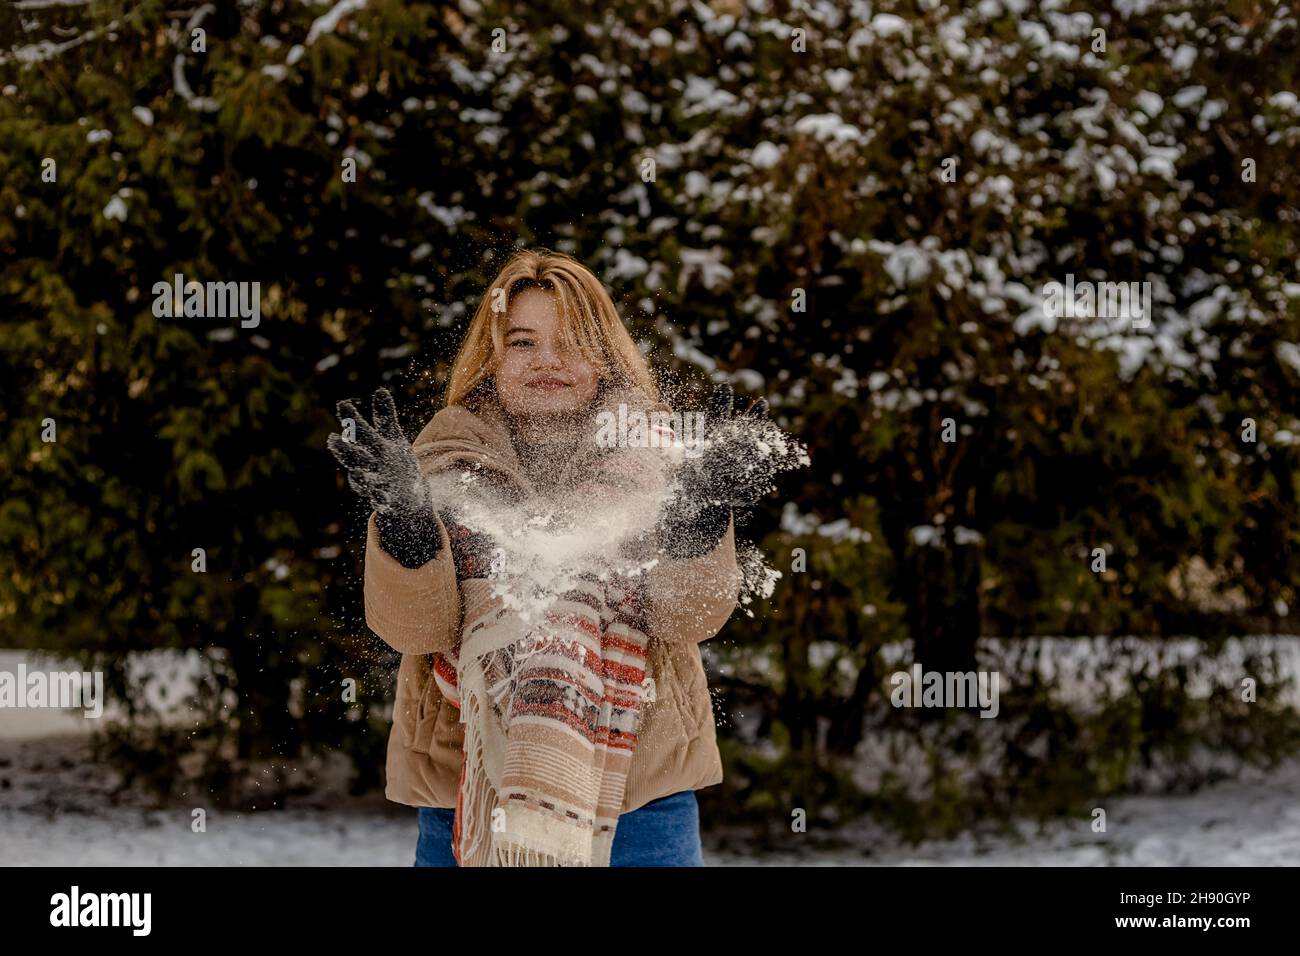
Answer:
xmin=495 ymin=289 xmax=599 ymax=419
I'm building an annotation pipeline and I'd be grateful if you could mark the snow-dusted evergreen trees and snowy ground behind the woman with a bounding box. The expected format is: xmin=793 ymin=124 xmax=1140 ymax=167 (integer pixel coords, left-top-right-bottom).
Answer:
xmin=0 ymin=0 xmax=1300 ymax=865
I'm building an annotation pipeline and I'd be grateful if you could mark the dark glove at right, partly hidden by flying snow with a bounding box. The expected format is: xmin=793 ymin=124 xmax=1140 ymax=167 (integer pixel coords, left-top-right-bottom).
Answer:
xmin=660 ymin=384 xmax=771 ymax=558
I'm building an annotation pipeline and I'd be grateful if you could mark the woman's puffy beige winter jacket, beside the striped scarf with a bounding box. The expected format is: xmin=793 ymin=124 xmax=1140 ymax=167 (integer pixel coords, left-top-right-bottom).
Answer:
xmin=365 ymin=387 xmax=741 ymax=813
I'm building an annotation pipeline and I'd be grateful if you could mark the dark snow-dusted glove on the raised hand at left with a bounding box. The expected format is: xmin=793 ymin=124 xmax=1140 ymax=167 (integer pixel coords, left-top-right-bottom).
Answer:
xmin=325 ymin=389 xmax=442 ymax=568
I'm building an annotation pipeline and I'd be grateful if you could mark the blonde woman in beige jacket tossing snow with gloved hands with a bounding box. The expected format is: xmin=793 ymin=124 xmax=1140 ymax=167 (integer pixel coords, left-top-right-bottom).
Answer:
xmin=329 ymin=251 xmax=766 ymax=866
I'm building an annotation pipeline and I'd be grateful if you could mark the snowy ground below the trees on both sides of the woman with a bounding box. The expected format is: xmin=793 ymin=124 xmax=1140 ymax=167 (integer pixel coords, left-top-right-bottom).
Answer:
xmin=0 ymin=652 xmax=1300 ymax=866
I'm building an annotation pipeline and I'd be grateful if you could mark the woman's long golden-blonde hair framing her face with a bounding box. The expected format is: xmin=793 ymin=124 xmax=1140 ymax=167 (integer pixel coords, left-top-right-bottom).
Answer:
xmin=447 ymin=248 xmax=659 ymax=408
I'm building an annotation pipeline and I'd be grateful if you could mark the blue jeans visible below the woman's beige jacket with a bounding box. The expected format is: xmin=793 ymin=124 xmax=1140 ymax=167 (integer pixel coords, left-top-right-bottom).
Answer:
xmin=415 ymin=790 xmax=705 ymax=866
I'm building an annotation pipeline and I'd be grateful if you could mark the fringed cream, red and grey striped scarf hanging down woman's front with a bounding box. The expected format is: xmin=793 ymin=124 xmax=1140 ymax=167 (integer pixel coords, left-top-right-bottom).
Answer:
xmin=434 ymin=527 xmax=653 ymax=866
